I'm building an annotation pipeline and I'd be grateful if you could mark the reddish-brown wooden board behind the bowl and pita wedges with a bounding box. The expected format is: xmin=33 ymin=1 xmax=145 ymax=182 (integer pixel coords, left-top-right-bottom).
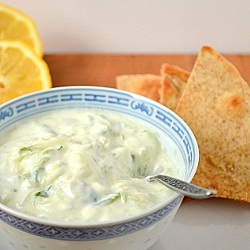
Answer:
xmin=44 ymin=54 xmax=250 ymax=87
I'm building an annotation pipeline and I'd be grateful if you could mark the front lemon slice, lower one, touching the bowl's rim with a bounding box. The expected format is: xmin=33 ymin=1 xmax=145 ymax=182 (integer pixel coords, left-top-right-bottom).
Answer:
xmin=0 ymin=40 xmax=52 ymax=104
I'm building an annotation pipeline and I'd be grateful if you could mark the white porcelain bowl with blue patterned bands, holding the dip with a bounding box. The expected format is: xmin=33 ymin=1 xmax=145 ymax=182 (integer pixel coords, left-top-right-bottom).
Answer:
xmin=0 ymin=86 xmax=199 ymax=250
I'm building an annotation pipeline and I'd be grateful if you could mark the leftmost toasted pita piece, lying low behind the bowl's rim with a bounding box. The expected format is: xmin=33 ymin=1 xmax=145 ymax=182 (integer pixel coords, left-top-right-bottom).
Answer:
xmin=116 ymin=74 xmax=161 ymax=101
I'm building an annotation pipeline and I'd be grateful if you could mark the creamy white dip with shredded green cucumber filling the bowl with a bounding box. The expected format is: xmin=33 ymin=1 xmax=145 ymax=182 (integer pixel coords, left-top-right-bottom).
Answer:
xmin=0 ymin=109 xmax=179 ymax=222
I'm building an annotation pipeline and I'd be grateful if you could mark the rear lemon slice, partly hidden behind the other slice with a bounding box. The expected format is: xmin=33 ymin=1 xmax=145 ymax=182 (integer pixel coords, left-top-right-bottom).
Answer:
xmin=0 ymin=4 xmax=43 ymax=57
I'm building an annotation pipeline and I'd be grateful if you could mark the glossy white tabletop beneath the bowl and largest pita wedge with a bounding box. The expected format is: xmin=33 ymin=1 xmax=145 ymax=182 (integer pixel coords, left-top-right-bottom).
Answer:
xmin=0 ymin=199 xmax=250 ymax=250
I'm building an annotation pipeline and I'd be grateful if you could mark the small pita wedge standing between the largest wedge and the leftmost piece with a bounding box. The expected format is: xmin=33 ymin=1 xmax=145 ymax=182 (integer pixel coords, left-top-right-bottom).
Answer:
xmin=159 ymin=63 xmax=190 ymax=110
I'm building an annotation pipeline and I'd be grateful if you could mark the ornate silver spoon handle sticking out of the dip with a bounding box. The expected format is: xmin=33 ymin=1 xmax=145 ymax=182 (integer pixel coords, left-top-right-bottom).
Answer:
xmin=148 ymin=175 xmax=217 ymax=199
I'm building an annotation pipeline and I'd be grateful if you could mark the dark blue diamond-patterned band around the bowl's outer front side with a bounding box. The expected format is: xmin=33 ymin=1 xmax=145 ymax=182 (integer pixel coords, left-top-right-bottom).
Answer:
xmin=0 ymin=195 xmax=183 ymax=241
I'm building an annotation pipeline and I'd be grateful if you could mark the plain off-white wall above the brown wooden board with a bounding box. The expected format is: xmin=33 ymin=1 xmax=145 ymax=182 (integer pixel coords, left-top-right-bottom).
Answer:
xmin=1 ymin=0 xmax=250 ymax=53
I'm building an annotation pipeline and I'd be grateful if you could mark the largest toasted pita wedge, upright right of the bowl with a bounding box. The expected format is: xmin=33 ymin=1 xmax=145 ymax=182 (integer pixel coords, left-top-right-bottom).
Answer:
xmin=176 ymin=46 xmax=250 ymax=202
